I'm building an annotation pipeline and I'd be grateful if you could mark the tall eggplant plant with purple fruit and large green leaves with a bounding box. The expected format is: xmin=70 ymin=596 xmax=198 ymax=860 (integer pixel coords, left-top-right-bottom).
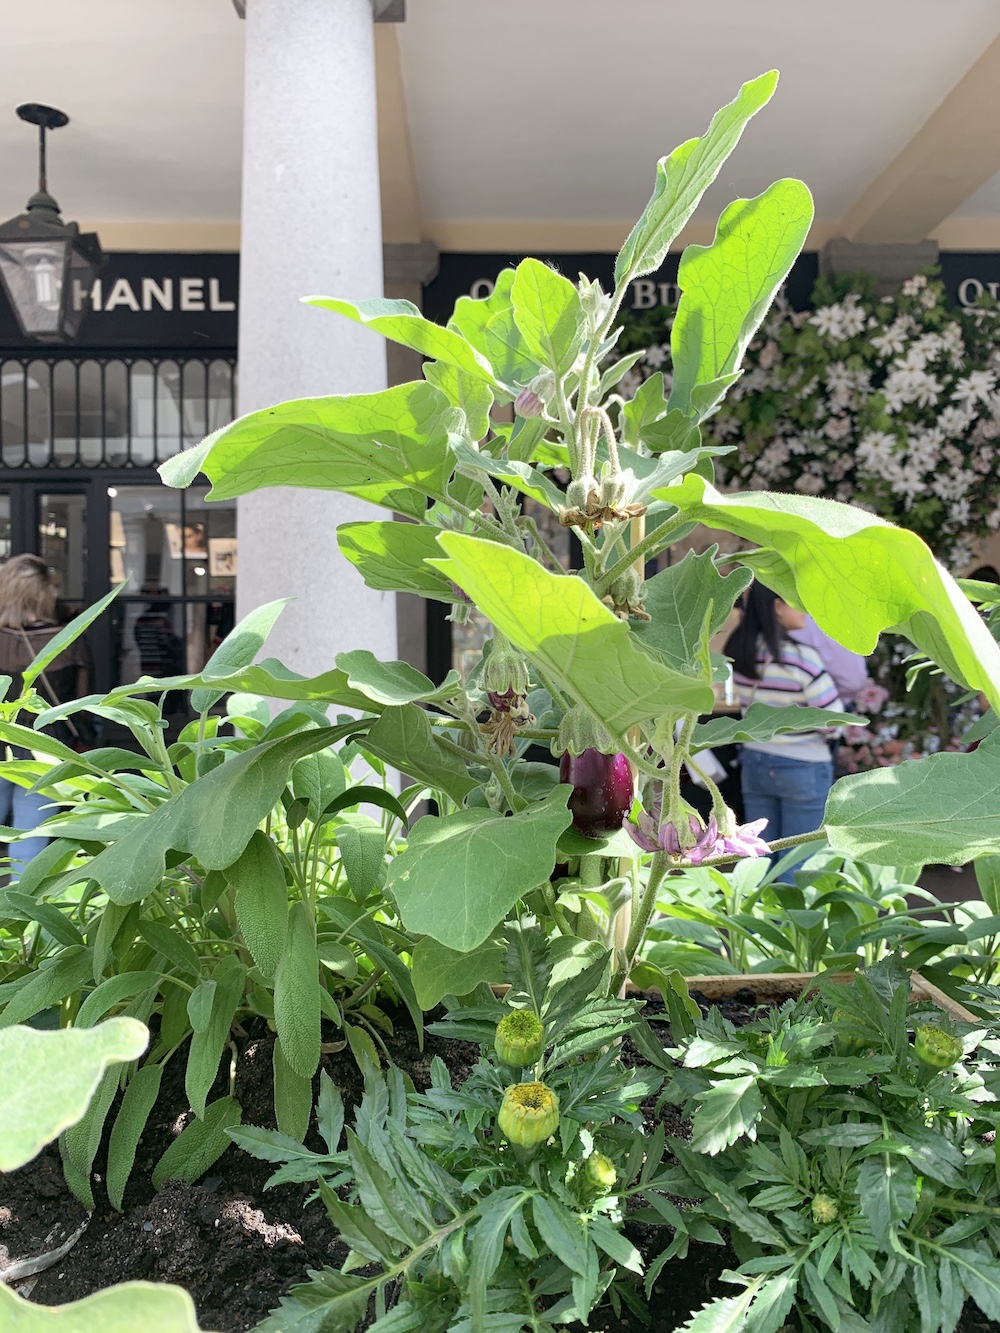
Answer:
xmin=72 ymin=80 xmax=1000 ymax=1005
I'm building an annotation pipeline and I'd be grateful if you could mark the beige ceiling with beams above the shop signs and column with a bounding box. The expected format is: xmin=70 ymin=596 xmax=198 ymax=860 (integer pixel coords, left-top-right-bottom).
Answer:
xmin=0 ymin=0 xmax=1000 ymax=249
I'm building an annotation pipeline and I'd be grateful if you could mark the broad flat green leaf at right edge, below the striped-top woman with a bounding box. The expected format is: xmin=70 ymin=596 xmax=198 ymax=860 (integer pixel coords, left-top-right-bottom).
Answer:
xmin=824 ymin=734 xmax=1000 ymax=865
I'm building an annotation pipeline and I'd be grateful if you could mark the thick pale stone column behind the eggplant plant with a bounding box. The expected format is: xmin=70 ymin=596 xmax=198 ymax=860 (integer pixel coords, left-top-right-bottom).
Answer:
xmin=237 ymin=0 xmax=396 ymax=674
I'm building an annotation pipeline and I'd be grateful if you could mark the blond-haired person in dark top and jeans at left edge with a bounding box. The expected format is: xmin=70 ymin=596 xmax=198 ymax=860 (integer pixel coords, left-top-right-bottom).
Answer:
xmin=0 ymin=555 xmax=91 ymax=880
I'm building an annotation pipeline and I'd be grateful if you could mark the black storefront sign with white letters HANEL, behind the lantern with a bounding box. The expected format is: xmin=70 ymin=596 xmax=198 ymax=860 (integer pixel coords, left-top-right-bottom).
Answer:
xmin=0 ymin=252 xmax=240 ymax=353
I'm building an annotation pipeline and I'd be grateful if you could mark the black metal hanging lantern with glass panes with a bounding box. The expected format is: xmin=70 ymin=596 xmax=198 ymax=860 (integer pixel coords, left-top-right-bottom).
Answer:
xmin=0 ymin=101 xmax=104 ymax=343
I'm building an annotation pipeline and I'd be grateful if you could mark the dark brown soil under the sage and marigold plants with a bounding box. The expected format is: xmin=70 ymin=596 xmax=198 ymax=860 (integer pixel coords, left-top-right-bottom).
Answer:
xmin=0 ymin=990 xmax=1000 ymax=1333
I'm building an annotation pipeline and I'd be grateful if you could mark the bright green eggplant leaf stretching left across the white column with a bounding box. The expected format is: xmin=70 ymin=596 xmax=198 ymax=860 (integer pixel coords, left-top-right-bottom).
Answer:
xmin=160 ymin=381 xmax=461 ymax=519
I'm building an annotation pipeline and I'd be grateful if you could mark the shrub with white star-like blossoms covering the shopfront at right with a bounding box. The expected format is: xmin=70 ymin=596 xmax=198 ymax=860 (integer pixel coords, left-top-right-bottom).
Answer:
xmin=623 ymin=273 xmax=1000 ymax=568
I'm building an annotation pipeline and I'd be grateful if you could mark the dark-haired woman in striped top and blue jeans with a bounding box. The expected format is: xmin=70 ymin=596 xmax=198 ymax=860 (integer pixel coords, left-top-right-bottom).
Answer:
xmin=725 ymin=583 xmax=843 ymax=841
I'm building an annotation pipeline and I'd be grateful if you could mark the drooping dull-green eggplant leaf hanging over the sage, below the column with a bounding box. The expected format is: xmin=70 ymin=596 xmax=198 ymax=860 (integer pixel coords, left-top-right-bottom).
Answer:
xmin=51 ymin=724 xmax=353 ymax=904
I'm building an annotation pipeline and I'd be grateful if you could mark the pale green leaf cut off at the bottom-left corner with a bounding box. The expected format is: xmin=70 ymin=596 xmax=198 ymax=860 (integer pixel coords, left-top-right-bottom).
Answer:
xmin=0 ymin=1282 xmax=206 ymax=1333
